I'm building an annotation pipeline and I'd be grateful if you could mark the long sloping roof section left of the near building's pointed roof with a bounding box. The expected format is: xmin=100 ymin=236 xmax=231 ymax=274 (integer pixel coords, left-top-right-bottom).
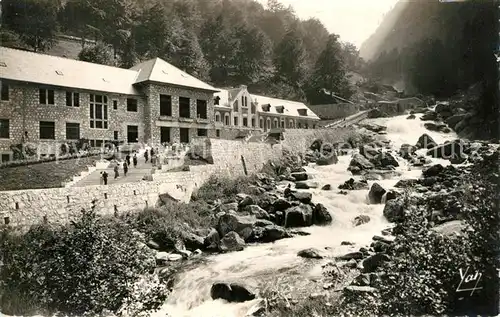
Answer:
xmin=0 ymin=47 xmax=138 ymax=95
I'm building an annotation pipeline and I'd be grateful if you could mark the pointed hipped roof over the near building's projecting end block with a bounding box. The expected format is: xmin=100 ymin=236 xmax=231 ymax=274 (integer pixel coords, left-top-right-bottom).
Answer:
xmin=131 ymin=58 xmax=218 ymax=91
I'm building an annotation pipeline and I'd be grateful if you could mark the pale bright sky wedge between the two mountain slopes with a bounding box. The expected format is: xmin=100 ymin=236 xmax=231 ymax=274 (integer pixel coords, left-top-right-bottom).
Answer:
xmin=259 ymin=0 xmax=398 ymax=48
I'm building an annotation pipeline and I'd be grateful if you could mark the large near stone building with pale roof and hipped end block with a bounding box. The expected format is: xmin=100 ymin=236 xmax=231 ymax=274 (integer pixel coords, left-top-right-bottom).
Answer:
xmin=0 ymin=47 xmax=217 ymax=161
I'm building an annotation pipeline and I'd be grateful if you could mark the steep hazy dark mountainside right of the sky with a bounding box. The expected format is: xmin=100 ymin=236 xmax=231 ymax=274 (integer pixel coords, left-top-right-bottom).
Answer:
xmin=362 ymin=0 xmax=499 ymax=138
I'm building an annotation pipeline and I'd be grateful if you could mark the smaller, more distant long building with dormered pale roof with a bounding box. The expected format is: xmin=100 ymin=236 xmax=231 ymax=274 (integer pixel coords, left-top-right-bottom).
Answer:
xmin=214 ymin=86 xmax=320 ymax=137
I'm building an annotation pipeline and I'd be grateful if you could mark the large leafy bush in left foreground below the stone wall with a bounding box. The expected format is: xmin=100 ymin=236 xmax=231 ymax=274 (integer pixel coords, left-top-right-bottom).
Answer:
xmin=0 ymin=210 xmax=166 ymax=316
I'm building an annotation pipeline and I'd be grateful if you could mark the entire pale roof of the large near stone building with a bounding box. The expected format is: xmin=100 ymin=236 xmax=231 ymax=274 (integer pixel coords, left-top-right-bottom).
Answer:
xmin=0 ymin=47 xmax=217 ymax=95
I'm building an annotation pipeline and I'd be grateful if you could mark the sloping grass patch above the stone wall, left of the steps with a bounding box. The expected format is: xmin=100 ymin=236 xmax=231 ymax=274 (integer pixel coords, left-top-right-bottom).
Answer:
xmin=0 ymin=156 xmax=99 ymax=191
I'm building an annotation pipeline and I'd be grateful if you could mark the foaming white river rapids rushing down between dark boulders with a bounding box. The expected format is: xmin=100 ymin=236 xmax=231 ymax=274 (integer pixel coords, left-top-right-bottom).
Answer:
xmin=6 ymin=114 xmax=456 ymax=317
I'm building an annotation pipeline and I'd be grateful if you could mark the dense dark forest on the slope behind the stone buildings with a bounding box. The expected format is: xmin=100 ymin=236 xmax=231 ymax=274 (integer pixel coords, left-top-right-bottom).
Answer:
xmin=1 ymin=0 xmax=362 ymax=104
